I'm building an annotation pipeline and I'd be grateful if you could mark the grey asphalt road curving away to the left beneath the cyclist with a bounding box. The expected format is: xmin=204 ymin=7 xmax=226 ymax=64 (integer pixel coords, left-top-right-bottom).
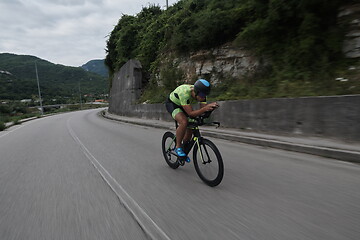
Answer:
xmin=0 ymin=110 xmax=360 ymax=240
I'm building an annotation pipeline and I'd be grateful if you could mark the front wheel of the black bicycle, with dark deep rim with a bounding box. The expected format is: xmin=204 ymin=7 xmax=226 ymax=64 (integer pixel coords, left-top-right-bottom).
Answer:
xmin=193 ymin=139 xmax=224 ymax=187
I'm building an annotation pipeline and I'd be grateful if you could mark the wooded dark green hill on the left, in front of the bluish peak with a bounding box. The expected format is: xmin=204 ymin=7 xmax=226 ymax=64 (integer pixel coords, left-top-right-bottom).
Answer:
xmin=0 ymin=53 xmax=108 ymax=102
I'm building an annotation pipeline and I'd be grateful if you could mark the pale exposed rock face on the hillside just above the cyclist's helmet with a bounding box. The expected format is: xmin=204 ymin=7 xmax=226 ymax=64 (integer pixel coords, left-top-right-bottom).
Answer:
xmin=174 ymin=44 xmax=261 ymax=84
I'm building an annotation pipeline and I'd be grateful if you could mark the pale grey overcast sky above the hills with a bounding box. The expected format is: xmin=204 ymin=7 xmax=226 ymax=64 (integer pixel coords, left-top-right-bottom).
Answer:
xmin=0 ymin=0 xmax=178 ymax=67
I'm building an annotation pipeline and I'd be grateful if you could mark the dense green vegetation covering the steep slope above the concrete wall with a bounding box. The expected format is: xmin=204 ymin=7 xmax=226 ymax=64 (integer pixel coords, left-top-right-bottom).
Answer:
xmin=105 ymin=0 xmax=360 ymax=102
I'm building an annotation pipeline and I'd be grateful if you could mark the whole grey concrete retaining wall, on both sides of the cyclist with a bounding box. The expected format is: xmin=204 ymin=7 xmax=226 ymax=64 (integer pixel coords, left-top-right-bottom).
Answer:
xmin=109 ymin=62 xmax=360 ymax=142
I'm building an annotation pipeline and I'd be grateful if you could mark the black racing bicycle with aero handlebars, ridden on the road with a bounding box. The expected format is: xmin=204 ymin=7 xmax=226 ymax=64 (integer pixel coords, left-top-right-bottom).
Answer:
xmin=162 ymin=112 xmax=224 ymax=187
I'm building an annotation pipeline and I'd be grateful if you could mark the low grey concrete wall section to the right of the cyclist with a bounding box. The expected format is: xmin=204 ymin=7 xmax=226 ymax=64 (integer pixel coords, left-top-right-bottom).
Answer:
xmin=214 ymin=95 xmax=360 ymax=141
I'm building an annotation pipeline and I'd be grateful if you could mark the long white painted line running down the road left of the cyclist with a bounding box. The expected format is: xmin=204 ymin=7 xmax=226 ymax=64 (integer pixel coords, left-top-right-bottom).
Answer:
xmin=67 ymin=118 xmax=170 ymax=240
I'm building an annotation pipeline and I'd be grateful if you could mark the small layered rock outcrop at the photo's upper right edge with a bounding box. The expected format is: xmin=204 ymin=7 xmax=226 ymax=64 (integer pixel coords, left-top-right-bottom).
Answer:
xmin=339 ymin=4 xmax=360 ymax=58
